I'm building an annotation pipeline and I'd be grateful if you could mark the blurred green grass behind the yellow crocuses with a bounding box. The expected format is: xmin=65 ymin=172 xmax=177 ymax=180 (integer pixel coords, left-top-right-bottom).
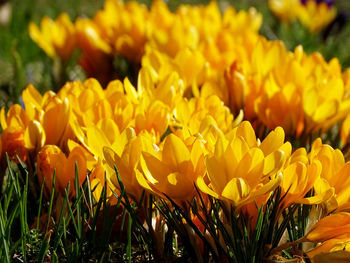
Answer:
xmin=0 ymin=0 xmax=350 ymax=107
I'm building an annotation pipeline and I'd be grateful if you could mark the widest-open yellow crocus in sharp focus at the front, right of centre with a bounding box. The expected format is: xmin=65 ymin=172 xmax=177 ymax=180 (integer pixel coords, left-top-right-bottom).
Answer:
xmin=197 ymin=122 xmax=291 ymax=207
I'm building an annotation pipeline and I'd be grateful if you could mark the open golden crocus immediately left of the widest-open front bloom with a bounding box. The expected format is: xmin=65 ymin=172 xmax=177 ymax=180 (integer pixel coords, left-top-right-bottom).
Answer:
xmin=136 ymin=134 xmax=205 ymax=205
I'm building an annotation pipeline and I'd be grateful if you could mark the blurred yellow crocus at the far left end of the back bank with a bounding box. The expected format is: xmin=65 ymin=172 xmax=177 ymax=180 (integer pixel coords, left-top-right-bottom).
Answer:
xmin=29 ymin=13 xmax=76 ymax=61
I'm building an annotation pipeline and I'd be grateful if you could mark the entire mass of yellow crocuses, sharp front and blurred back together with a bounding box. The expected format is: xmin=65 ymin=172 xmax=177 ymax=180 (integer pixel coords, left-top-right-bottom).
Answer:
xmin=0 ymin=0 xmax=350 ymax=261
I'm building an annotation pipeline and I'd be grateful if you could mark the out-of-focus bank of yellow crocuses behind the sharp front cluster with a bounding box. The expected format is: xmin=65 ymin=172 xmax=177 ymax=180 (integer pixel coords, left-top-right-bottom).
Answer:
xmin=30 ymin=1 xmax=350 ymax=137
